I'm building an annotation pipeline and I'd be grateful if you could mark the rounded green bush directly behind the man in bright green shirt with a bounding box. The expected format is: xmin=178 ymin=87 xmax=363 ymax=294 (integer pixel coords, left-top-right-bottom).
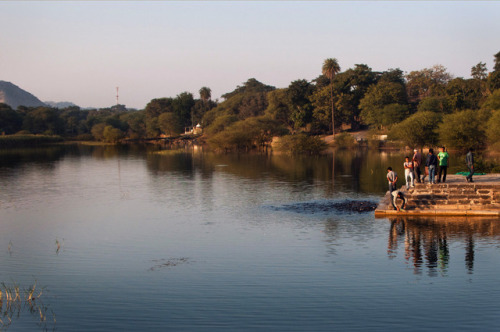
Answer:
xmin=389 ymin=111 xmax=441 ymax=148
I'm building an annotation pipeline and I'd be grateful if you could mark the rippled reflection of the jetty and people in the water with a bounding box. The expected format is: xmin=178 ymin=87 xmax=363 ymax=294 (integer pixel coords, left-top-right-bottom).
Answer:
xmin=387 ymin=217 xmax=500 ymax=277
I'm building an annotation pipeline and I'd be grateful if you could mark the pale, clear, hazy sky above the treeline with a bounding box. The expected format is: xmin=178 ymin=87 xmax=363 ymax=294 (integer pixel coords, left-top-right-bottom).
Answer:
xmin=0 ymin=1 xmax=500 ymax=109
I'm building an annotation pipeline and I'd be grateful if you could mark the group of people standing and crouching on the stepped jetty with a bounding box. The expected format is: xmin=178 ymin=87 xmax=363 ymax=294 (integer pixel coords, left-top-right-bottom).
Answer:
xmin=387 ymin=146 xmax=474 ymax=211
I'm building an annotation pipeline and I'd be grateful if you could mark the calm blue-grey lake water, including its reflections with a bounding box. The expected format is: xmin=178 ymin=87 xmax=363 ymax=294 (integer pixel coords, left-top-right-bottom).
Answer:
xmin=0 ymin=146 xmax=500 ymax=331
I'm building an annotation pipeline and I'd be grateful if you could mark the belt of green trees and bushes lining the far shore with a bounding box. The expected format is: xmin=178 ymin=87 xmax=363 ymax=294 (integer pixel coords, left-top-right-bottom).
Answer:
xmin=0 ymin=52 xmax=500 ymax=152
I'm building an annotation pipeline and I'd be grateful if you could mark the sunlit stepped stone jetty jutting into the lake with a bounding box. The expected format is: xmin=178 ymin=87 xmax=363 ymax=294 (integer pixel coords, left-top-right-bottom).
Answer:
xmin=375 ymin=174 xmax=500 ymax=218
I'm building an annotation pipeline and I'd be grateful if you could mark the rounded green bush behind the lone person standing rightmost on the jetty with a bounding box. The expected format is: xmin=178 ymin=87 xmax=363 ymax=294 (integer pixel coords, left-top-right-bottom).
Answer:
xmin=437 ymin=110 xmax=491 ymax=150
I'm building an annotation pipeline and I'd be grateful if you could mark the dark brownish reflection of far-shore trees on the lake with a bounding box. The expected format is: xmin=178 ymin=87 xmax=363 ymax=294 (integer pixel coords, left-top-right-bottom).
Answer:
xmin=146 ymin=150 xmax=418 ymax=195
